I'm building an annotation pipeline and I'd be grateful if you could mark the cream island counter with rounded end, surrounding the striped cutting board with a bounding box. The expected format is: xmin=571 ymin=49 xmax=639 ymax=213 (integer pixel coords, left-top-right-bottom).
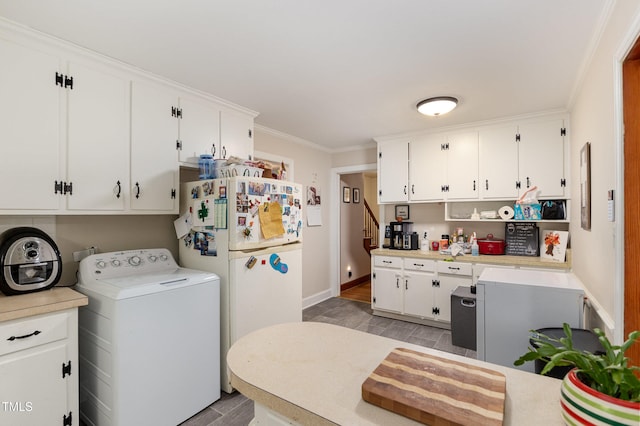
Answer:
xmin=227 ymin=322 xmax=562 ymax=426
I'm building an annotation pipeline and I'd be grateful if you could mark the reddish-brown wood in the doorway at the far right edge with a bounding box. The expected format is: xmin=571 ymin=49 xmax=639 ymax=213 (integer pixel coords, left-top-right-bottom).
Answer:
xmin=622 ymin=35 xmax=640 ymax=365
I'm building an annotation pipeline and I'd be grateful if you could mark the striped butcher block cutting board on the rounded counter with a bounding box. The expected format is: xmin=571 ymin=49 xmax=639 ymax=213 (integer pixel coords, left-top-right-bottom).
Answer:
xmin=362 ymin=348 xmax=507 ymax=426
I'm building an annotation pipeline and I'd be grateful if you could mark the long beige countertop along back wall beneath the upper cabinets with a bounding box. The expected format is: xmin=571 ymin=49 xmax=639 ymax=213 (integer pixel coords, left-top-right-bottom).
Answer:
xmin=371 ymin=249 xmax=571 ymax=270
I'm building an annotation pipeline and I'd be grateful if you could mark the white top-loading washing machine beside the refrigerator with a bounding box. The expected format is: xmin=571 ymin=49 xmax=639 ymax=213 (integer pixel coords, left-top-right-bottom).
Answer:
xmin=75 ymin=249 xmax=220 ymax=426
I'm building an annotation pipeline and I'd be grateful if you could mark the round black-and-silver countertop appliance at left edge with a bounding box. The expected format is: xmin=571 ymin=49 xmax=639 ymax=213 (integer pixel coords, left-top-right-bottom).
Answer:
xmin=0 ymin=226 xmax=62 ymax=295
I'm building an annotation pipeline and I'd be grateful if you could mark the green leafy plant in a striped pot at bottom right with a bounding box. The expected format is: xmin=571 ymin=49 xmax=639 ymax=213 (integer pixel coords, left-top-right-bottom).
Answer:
xmin=514 ymin=323 xmax=640 ymax=426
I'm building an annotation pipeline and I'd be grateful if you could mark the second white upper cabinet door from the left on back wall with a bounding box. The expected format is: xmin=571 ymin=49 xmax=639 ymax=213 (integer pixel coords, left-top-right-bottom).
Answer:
xmin=409 ymin=135 xmax=447 ymax=201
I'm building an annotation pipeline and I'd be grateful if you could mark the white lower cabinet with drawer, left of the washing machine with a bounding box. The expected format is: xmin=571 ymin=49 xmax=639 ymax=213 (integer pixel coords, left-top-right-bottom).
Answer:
xmin=0 ymin=308 xmax=80 ymax=426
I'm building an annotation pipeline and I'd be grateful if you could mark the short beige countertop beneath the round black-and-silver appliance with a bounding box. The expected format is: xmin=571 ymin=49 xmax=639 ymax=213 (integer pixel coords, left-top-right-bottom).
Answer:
xmin=0 ymin=287 xmax=89 ymax=322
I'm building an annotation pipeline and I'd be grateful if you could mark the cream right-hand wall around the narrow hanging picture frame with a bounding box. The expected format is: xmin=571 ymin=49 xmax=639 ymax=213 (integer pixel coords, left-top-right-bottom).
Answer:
xmin=570 ymin=0 xmax=640 ymax=341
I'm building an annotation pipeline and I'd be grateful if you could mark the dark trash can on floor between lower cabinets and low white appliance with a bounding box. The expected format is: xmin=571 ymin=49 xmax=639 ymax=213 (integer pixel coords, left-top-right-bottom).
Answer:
xmin=451 ymin=286 xmax=476 ymax=351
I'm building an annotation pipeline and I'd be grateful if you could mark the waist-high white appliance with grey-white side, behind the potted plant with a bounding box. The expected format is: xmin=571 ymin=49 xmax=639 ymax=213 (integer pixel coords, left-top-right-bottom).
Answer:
xmin=476 ymin=268 xmax=584 ymax=372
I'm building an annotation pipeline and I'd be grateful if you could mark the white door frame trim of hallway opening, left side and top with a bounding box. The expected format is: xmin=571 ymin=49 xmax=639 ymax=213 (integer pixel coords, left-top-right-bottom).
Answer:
xmin=329 ymin=163 xmax=378 ymax=297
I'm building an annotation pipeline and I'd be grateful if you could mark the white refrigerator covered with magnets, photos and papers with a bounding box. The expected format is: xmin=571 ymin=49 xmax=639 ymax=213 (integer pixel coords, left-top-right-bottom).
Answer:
xmin=179 ymin=177 xmax=303 ymax=392
